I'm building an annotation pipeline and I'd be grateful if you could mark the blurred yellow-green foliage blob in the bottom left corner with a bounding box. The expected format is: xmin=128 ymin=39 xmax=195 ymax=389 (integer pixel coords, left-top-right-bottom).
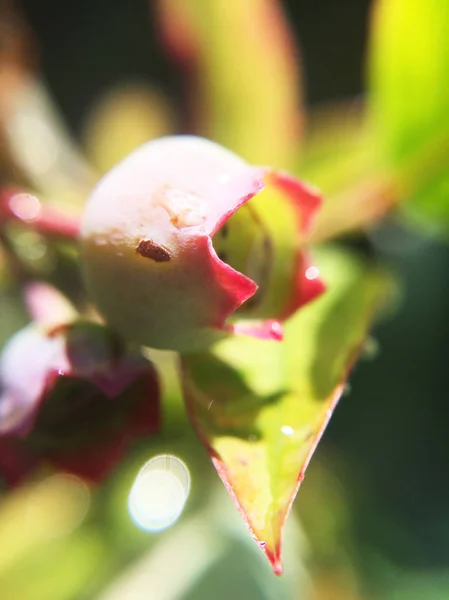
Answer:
xmin=0 ymin=475 xmax=100 ymax=600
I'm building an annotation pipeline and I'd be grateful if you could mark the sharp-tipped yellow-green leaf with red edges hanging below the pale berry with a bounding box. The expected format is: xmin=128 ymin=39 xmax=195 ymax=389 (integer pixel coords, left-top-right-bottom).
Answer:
xmin=182 ymin=249 xmax=390 ymax=574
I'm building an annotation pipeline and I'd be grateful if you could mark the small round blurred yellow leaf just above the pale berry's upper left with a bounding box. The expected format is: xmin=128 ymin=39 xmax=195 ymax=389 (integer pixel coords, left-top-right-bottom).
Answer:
xmin=84 ymin=84 xmax=175 ymax=173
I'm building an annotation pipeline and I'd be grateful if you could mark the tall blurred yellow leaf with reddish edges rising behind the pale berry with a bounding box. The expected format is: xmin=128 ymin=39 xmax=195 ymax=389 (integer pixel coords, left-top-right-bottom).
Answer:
xmin=158 ymin=0 xmax=302 ymax=169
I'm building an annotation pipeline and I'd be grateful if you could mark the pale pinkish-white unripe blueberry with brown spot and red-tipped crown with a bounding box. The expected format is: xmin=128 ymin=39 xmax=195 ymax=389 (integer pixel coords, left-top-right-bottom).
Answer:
xmin=82 ymin=136 xmax=323 ymax=352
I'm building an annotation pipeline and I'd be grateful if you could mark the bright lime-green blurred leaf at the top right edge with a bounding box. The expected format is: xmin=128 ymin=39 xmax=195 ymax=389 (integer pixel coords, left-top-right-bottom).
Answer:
xmin=369 ymin=0 xmax=449 ymax=226
